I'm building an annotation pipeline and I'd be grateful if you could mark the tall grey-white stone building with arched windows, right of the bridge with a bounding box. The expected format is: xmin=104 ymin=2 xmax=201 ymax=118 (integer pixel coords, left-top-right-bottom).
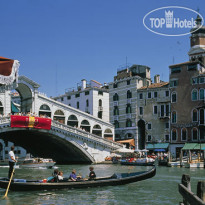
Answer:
xmin=109 ymin=65 xmax=151 ymax=149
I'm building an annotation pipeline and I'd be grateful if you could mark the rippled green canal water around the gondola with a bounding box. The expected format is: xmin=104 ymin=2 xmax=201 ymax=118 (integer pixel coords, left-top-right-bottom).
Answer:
xmin=0 ymin=164 xmax=205 ymax=205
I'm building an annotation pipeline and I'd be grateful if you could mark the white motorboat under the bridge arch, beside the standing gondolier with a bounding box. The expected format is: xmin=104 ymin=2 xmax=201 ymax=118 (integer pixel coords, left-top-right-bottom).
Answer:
xmin=20 ymin=158 xmax=56 ymax=168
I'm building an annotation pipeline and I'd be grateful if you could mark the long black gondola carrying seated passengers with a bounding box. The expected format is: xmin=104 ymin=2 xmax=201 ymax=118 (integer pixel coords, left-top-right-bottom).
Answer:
xmin=0 ymin=167 xmax=156 ymax=191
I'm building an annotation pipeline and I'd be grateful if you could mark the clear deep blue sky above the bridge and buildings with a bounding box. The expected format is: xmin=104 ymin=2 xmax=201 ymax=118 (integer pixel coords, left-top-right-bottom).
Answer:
xmin=0 ymin=0 xmax=205 ymax=97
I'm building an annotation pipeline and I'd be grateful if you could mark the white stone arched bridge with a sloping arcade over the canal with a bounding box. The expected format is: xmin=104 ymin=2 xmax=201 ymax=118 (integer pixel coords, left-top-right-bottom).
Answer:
xmin=0 ymin=76 xmax=122 ymax=163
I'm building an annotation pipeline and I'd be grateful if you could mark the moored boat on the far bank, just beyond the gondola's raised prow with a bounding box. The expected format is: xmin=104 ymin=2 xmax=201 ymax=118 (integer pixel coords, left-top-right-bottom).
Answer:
xmin=120 ymin=157 xmax=155 ymax=166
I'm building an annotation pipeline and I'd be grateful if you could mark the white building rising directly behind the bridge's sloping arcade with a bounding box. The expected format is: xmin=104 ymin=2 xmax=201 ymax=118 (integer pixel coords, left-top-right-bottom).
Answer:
xmin=53 ymin=79 xmax=109 ymax=122
